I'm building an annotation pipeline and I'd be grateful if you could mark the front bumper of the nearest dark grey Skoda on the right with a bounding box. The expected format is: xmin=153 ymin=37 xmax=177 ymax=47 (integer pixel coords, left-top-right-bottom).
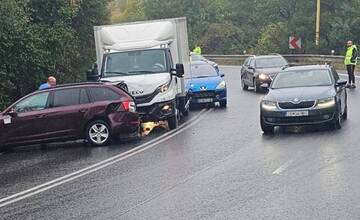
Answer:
xmin=261 ymin=107 xmax=337 ymax=126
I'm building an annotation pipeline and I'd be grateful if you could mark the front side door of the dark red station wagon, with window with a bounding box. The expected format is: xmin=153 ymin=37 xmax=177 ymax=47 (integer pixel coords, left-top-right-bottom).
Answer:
xmin=0 ymin=92 xmax=50 ymax=144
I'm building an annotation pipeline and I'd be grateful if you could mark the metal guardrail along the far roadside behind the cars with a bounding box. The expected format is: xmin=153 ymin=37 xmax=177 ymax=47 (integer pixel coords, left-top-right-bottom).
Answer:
xmin=204 ymin=54 xmax=344 ymax=65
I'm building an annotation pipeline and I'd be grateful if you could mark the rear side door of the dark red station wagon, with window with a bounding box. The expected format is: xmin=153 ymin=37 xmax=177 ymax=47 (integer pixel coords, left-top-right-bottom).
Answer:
xmin=47 ymin=88 xmax=90 ymax=139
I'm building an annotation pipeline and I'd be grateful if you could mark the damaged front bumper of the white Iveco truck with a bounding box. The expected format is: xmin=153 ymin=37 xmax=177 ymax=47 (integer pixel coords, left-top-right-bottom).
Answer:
xmin=137 ymin=100 xmax=175 ymax=122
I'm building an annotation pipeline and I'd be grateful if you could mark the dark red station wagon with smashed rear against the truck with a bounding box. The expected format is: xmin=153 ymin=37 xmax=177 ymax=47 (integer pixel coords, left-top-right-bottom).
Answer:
xmin=0 ymin=83 xmax=140 ymax=146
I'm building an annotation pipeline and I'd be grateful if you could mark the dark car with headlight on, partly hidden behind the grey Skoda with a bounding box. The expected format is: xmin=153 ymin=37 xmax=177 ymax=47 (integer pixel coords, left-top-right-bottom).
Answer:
xmin=241 ymin=54 xmax=289 ymax=92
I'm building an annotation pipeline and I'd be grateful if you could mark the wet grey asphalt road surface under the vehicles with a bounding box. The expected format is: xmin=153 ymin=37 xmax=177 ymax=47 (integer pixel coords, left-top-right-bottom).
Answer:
xmin=0 ymin=67 xmax=360 ymax=219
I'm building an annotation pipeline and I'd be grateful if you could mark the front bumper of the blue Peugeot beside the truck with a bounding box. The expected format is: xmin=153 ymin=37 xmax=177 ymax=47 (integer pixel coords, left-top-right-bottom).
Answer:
xmin=191 ymin=89 xmax=227 ymax=104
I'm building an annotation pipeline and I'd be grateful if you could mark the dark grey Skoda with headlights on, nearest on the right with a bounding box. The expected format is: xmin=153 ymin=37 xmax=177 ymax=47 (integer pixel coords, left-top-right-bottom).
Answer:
xmin=260 ymin=65 xmax=347 ymax=133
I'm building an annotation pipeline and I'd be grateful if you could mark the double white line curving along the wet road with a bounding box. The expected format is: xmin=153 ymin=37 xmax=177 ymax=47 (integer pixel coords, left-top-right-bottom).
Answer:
xmin=0 ymin=109 xmax=213 ymax=208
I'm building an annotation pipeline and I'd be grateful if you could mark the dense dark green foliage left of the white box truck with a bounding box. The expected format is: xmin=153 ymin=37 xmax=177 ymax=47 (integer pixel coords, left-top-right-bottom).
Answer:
xmin=0 ymin=0 xmax=108 ymax=109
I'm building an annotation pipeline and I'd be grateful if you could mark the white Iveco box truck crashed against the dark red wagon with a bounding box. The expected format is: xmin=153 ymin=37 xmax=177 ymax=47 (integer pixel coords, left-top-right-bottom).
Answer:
xmin=88 ymin=18 xmax=191 ymax=129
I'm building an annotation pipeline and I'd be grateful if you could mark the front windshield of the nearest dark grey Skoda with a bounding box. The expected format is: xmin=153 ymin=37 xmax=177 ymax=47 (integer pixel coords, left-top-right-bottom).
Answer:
xmin=271 ymin=69 xmax=332 ymax=89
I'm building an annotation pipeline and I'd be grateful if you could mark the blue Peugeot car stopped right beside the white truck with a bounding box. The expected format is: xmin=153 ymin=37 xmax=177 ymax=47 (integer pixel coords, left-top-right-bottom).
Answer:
xmin=188 ymin=61 xmax=227 ymax=108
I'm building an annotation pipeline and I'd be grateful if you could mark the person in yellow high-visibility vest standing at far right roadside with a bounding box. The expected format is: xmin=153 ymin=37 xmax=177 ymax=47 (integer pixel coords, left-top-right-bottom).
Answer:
xmin=344 ymin=40 xmax=357 ymax=88
